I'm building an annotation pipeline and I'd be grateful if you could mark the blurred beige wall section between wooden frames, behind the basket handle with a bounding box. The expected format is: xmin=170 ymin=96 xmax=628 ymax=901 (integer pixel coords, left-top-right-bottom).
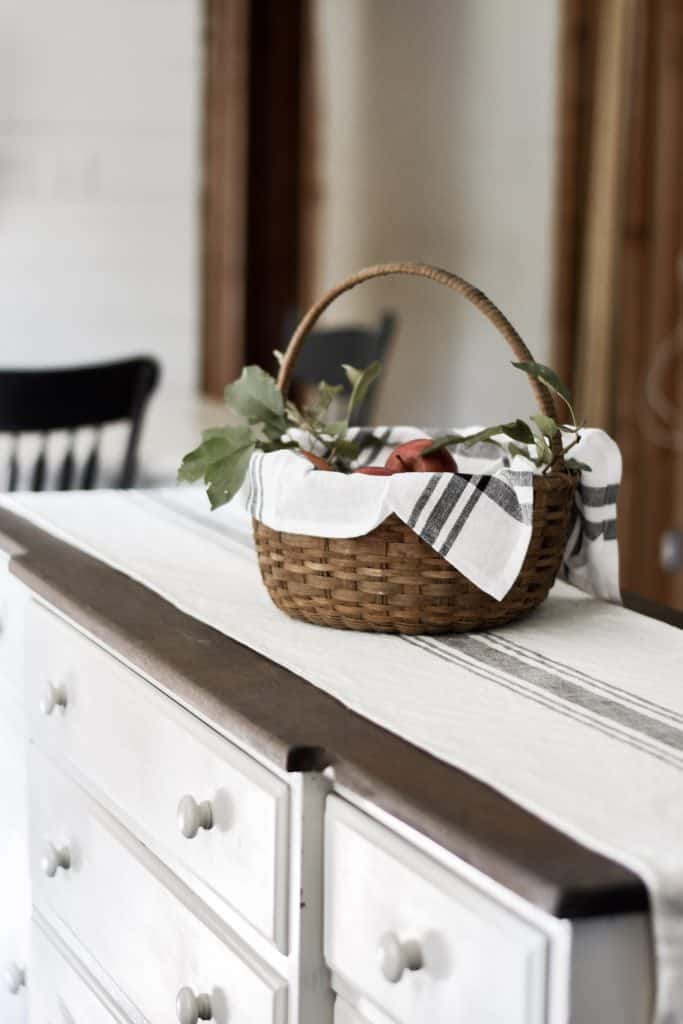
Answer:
xmin=315 ymin=0 xmax=559 ymax=425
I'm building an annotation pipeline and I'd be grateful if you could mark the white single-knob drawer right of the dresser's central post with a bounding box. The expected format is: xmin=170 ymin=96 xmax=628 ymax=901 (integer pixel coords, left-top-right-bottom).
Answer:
xmin=325 ymin=797 xmax=547 ymax=1024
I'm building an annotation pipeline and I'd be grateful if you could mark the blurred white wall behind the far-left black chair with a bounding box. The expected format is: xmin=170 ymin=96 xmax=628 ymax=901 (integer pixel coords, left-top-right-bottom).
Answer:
xmin=0 ymin=0 xmax=201 ymax=394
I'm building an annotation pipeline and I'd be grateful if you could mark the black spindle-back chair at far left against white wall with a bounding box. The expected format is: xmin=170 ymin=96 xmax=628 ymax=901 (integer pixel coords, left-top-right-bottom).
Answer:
xmin=0 ymin=357 xmax=160 ymax=490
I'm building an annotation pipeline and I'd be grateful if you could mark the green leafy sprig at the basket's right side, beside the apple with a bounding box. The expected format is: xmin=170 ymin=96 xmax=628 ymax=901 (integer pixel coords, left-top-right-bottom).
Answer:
xmin=423 ymin=362 xmax=591 ymax=473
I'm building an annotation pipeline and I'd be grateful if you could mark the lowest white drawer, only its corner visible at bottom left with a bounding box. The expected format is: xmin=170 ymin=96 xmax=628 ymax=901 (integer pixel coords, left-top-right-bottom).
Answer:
xmin=29 ymin=923 xmax=128 ymax=1024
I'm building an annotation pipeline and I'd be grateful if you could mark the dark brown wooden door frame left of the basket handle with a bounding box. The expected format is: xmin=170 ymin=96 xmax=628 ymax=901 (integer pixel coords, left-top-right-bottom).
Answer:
xmin=201 ymin=0 xmax=310 ymax=396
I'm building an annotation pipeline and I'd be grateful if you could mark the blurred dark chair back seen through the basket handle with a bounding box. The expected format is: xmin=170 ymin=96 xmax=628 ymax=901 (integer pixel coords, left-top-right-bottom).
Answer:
xmin=284 ymin=312 xmax=396 ymax=426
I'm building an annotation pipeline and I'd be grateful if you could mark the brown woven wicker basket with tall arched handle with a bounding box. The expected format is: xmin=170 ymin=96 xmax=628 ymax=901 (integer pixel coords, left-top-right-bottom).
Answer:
xmin=254 ymin=263 xmax=575 ymax=633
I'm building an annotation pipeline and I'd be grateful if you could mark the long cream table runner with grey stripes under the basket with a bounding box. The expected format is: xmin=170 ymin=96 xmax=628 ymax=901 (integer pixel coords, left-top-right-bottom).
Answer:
xmin=3 ymin=486 xmax=683 ymax=1024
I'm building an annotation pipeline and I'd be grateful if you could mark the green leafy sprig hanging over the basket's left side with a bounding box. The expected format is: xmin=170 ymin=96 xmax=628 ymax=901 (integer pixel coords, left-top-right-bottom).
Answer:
xmin=178 ymin=360 xmax=380 ymax=509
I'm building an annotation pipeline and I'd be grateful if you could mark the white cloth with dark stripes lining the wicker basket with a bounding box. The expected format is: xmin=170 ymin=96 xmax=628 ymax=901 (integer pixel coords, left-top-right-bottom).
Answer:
xmin=247 ymin=427 xmax=622 ymax=601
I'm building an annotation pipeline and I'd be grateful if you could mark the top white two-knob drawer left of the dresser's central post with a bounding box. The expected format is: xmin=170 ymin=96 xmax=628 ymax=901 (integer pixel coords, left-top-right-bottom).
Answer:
xmin=27 ymin=604 xmax=289 ymax=951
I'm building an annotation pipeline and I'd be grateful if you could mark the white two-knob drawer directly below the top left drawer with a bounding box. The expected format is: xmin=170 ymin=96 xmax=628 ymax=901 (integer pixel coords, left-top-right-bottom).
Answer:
xmin=30 ymin=748 xmax=287 ymax=1024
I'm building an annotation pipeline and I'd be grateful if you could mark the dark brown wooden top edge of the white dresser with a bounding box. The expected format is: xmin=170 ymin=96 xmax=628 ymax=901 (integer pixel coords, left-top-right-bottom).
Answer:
xmin=0 ymin=509 xmax=648 ymax=918
